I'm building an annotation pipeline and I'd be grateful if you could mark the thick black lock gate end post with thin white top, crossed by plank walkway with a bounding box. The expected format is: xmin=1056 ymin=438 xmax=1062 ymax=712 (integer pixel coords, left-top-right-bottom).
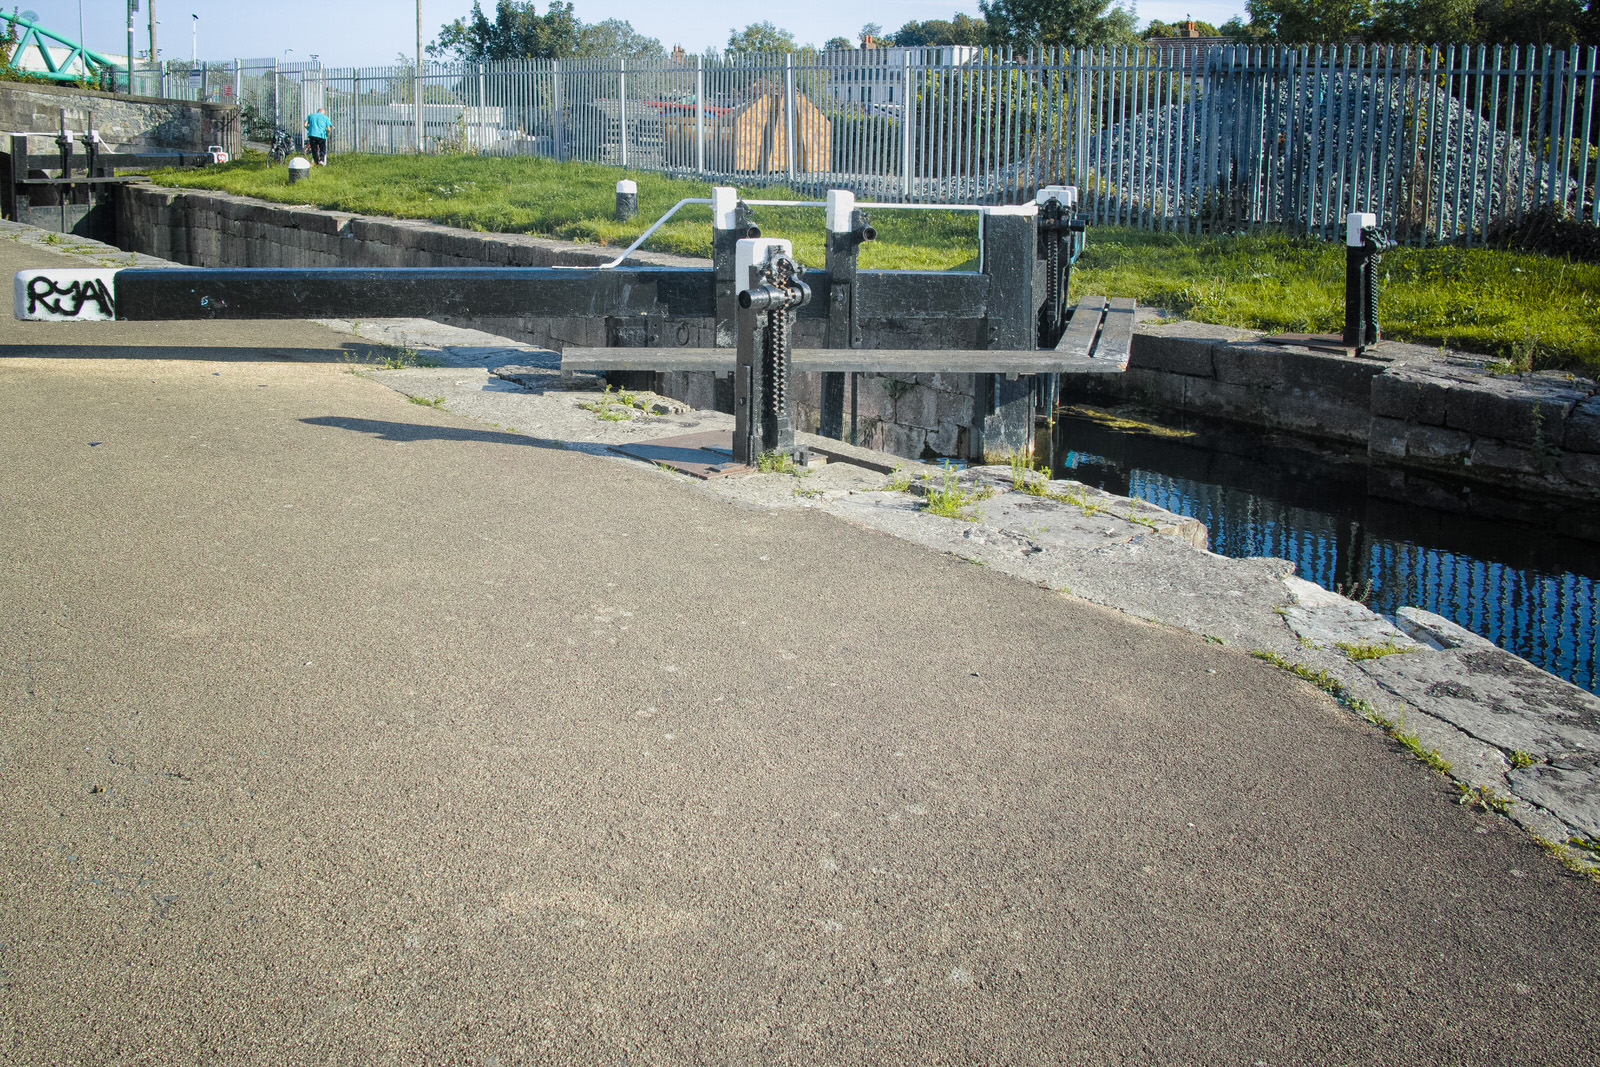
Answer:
xmin=973 ymin=205 xmax=1043 ymax=464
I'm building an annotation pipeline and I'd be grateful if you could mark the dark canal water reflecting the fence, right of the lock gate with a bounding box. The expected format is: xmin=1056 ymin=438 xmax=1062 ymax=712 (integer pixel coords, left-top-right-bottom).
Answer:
xmin=1053 ymin=408 xmax=1600 ymax=693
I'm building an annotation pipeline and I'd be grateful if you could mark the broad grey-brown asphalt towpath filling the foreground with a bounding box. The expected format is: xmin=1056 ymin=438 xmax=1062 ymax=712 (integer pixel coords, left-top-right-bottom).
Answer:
xmin=0 ymin=233 xmax=1600 ymax=1065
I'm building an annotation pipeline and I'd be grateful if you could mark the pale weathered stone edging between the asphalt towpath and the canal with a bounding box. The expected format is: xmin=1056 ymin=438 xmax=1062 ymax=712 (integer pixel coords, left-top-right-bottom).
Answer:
xmin=0 ymin=217 xmax=1600 ymax=870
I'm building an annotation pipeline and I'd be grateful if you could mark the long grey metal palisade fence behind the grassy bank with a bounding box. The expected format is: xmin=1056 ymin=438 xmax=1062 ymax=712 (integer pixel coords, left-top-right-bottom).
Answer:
xmin=134 ymin=42 xmax=1600 ymax=242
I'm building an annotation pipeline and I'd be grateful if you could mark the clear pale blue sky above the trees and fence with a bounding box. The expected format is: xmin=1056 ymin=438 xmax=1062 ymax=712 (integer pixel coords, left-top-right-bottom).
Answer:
xmin=31 ymin=0 xmax=1245 ymax=67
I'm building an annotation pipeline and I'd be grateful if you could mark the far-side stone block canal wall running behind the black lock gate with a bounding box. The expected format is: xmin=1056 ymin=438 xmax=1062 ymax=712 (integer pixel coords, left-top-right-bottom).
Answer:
xmin=117 ymin=186 xmax=1600 ymax=501
